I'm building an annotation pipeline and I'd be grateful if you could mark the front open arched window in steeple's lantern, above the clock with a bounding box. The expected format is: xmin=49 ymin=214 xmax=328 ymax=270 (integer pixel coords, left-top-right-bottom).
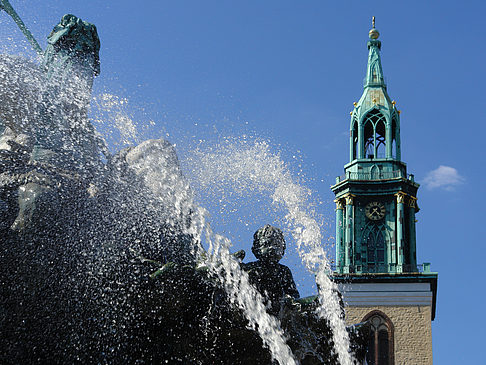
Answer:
xmin=364 ymin=109 xmax=386 ymax=158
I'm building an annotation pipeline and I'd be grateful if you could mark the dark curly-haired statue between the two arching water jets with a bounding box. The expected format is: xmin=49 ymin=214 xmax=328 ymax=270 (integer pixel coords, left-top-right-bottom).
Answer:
xmin=243 ymin=224 xmax=300 ymax=313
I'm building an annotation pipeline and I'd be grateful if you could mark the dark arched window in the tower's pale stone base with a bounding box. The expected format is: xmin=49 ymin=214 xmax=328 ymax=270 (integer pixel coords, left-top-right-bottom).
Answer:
xmin=363 ymin=310 xmax=394 ymax=365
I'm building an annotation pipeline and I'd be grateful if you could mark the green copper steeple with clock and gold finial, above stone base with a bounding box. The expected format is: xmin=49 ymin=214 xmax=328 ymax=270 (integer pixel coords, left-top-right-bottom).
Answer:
xmin=331 ymin=19 xmax=419 ymax=273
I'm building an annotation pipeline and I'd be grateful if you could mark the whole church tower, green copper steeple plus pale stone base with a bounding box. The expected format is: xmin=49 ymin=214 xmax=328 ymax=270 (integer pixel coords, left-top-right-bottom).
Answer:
xmin=331 ymin=17 xmax=437 ymax=365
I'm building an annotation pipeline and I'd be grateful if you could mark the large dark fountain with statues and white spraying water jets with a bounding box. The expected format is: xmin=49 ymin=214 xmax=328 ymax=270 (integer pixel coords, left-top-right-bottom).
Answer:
xmin=0 ymin=0 xmax=368 ymax=365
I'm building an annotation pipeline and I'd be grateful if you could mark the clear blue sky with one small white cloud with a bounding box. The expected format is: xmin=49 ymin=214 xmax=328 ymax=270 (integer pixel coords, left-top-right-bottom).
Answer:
xmin=0 ymin=0 xmax=486 ymax=364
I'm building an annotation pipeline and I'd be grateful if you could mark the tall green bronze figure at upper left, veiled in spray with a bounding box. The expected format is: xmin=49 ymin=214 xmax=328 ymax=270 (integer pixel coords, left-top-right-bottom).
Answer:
xmin=33 ymin=14 xmax=101 ymax=164
